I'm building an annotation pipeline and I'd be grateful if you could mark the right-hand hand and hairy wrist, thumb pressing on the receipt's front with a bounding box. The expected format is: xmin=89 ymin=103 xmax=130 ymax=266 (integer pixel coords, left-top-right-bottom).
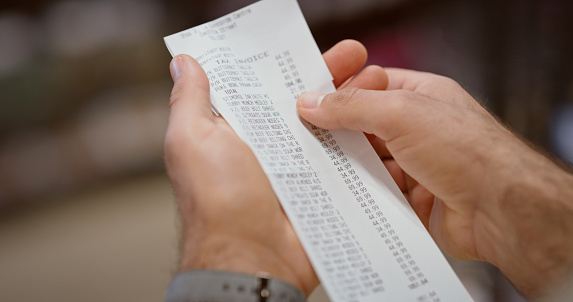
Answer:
xmin=297 ymin=69 xmax=573 ymax=296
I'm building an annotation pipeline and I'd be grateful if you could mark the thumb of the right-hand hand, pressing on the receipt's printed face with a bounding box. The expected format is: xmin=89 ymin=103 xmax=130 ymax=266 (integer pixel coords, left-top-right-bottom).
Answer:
xmin=297 ymin=87 xmax=411 ymax=140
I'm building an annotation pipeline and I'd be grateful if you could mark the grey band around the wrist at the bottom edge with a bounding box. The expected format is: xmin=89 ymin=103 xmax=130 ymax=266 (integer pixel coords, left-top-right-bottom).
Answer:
xmin=165 ymin=270 xmax=305 ymax=302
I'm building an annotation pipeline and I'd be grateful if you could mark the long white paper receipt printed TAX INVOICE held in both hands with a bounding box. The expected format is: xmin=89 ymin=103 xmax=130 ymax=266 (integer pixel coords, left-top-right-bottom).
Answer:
xmin=165 ymin=0 xmax=472 ymax=302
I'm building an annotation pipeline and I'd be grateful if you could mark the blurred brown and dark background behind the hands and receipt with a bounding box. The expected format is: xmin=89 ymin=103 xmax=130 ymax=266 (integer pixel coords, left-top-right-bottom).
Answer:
xmin=0 ymin=0 xmax=573 ymax=301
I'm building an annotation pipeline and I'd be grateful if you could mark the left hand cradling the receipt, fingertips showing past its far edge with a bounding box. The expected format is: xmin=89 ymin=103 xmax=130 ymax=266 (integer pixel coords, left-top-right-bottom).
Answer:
xmin=165 ymin=41 xmax=387 ymax=295
